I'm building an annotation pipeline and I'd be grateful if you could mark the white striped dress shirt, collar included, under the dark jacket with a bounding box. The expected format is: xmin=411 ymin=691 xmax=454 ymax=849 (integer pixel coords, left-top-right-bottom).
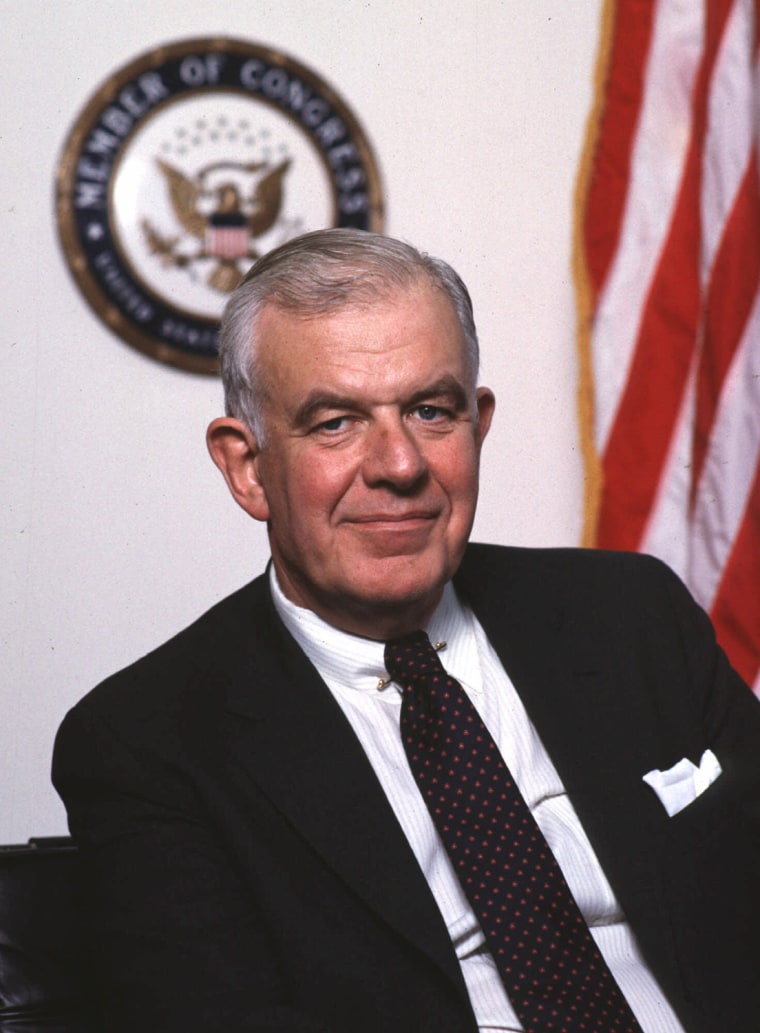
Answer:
xmin=271 ymin=565 xmax=684 ymax=1033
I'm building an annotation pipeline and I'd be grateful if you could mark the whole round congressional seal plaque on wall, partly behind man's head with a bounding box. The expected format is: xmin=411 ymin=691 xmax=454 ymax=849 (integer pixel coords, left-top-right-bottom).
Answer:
xmin=57 ymin=38 xmax=383 ymax=372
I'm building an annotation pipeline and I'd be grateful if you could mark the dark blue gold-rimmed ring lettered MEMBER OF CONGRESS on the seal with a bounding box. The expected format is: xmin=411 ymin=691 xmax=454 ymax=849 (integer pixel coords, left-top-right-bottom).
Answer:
xmin=57 ymin=38 xmax=383 ymax=372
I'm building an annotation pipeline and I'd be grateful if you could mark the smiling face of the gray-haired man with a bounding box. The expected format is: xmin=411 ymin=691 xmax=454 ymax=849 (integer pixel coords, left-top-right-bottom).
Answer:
xmin=209 ymin=284 xmax=494 ymax=638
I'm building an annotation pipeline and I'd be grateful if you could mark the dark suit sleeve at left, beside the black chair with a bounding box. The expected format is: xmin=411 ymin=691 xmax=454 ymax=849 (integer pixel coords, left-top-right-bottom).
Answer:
xmin=53 ymin=705 xmax=326 ymax=1033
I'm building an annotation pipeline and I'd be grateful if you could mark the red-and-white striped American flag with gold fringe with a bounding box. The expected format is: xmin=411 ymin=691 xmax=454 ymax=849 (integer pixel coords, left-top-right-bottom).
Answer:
xmin=576 ymin=0 xmax=760 ymax=694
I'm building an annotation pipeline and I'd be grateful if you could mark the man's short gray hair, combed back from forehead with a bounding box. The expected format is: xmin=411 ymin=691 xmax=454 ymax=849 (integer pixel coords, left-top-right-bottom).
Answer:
xmin=219 ymin=229 xmax=479 ymax=444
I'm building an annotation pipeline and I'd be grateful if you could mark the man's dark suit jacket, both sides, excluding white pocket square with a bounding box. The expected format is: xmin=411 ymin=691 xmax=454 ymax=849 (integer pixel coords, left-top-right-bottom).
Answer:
xmin=54 ymin=545 xmax=760 ymax=1033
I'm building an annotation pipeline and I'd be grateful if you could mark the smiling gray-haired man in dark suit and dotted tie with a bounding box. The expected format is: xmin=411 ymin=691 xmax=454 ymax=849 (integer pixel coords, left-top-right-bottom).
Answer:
xmin=54 ymin=230 xmax=760 ymax=1033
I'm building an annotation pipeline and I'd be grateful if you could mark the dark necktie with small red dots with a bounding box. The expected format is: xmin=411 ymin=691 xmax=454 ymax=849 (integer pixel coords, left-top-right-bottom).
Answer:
xmin=385 ymin=631 xmax=640 ymax=1033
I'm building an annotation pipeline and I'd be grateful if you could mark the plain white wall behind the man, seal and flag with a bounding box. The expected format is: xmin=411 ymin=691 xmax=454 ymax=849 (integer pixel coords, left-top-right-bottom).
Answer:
xmin=0 ymin=0 xmax=600 ymax=842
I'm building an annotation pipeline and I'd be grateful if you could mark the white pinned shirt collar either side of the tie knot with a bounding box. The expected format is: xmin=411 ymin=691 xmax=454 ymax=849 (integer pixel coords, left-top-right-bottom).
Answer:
xmin=270 ymin=563 xmax=482 ymax=695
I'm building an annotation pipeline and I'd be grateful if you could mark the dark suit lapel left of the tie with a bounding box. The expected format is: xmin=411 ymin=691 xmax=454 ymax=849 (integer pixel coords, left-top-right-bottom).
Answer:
xmin=212 ymin=591 xmax=465 ymax=994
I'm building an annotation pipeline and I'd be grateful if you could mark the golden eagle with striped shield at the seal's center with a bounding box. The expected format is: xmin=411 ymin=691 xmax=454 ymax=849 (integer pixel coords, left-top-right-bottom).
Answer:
xmin=141 ymin=158 xmax=290 ymax=294
